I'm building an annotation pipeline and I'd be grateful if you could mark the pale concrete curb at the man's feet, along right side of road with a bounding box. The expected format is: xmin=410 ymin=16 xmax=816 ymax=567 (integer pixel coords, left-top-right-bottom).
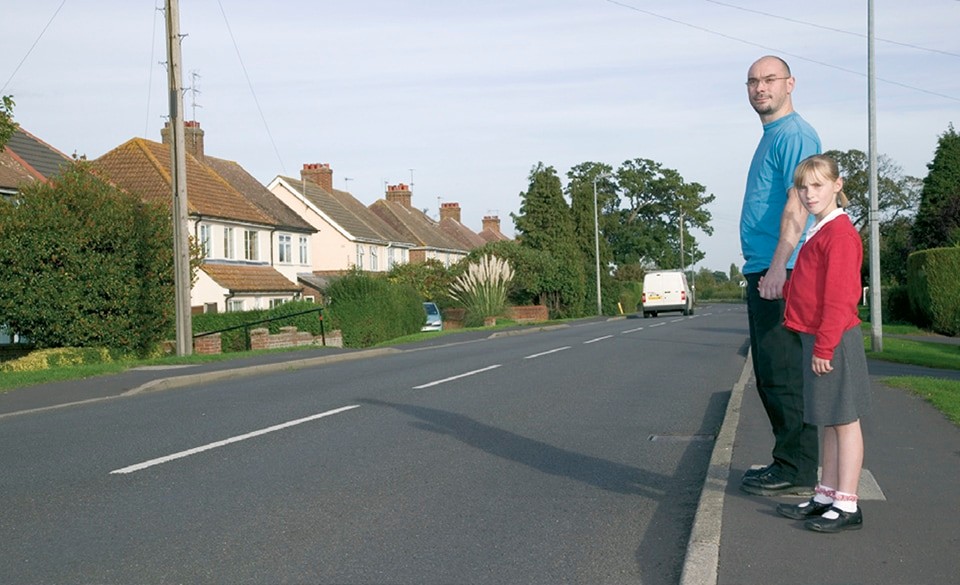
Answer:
xmin=680 ymin=353 xmax=753 ymax=585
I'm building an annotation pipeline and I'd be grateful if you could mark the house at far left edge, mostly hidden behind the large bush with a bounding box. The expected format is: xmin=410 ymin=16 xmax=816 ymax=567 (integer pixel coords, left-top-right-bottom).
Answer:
xmin=0 ymin=126 xmax=71 ymax=345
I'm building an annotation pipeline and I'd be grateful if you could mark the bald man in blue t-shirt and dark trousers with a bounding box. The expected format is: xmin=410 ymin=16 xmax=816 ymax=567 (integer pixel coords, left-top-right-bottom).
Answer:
xmin=740 ymin=56 xmax=820 ymax=496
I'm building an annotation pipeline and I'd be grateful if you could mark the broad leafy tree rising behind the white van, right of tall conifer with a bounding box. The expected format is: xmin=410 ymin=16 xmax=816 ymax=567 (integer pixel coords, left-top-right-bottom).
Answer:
xmin=610 ymin=159 xmax=715 ymax=268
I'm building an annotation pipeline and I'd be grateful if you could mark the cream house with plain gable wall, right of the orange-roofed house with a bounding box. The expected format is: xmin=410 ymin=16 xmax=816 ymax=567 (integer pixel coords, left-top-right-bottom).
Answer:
xmin=267 ymin=163 xmax=416 ymax=274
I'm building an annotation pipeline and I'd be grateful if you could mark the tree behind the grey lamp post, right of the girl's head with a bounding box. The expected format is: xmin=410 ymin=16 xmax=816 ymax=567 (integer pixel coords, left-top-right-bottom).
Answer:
xmin=825 ymin=150 xmax=921 ymax=233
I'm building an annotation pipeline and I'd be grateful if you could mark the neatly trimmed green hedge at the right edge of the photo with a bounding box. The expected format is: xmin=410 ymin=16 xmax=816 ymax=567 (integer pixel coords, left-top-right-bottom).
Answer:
xmin=907 ymin=248 xmax=960 ymax=336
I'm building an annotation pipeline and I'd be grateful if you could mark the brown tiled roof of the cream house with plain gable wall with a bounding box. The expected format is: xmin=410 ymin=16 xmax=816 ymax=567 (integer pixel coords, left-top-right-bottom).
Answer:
xmin=280 ymin=177 xmax=412 ymax=244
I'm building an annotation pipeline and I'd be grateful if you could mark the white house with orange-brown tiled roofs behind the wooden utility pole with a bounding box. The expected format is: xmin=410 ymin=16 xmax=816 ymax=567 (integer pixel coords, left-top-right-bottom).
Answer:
xmin=93 ymin=122 xmax=315 ymax=312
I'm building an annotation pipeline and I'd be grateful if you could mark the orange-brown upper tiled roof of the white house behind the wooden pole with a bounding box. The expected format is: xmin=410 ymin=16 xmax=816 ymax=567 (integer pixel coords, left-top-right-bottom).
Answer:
xmin=93 ymin=138 xmax=277 ymax=225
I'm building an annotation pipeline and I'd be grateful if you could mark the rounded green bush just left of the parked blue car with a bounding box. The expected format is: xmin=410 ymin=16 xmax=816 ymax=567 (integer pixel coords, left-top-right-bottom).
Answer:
xmin=327 ymin=270 xmax=426 ymax=347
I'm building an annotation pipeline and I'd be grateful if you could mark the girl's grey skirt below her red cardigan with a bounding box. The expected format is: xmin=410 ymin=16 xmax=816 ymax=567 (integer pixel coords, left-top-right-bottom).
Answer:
xmin=800 ymin=327 xmax=871 ymax=426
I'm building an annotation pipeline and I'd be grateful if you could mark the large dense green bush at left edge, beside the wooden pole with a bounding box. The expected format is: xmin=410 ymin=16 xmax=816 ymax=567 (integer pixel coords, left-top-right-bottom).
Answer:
xmin=0 ymin=161 xmax=174 ymax=355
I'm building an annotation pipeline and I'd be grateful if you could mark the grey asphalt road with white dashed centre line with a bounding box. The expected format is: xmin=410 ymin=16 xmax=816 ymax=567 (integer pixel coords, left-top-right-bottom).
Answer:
xmin=0 ymin=306 xmax=747 ymax=585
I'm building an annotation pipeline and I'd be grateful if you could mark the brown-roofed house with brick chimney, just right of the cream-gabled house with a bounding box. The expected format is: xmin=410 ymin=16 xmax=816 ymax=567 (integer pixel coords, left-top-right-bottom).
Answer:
xmin=370 ymin=183 xmax=470 ymax=266
